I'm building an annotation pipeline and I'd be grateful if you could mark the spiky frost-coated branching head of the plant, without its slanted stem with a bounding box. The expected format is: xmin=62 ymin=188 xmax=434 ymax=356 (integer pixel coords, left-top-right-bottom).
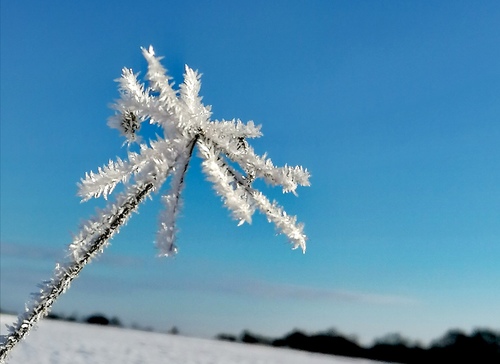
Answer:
xmin=78 ymin=47 xmax=309 ymax=255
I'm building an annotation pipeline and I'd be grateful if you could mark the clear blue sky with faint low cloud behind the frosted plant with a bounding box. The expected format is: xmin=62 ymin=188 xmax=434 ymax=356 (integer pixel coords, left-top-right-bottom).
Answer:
xmin=0 ymin=0 xmax=500 ymax=342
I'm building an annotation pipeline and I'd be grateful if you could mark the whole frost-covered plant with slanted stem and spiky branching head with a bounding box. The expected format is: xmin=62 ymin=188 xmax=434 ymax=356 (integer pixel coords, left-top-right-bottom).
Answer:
xmin=0 ymin=47 xmax=309 ymax=361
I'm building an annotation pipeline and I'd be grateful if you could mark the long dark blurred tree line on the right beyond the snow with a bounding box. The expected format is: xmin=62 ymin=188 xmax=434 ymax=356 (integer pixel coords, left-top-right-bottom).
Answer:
xmin=217 ymin=329 xmax=500 ymax=364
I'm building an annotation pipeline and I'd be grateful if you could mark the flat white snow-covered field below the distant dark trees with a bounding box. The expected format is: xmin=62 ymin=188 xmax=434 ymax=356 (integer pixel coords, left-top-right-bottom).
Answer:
xmin=0 ymin=315 xmax=375 ymax=364
